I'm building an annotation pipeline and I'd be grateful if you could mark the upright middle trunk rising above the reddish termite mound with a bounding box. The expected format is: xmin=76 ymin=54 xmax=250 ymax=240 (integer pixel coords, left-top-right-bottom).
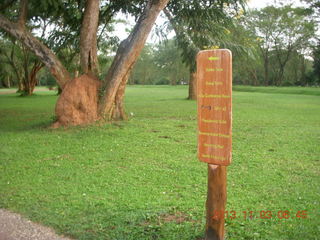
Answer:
xmin=80 ymin=0 xmax=99 ymax=76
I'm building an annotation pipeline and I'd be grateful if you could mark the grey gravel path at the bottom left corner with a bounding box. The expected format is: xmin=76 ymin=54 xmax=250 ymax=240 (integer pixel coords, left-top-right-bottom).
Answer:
xmin=0 ymin=209 xmax=71 ymax=240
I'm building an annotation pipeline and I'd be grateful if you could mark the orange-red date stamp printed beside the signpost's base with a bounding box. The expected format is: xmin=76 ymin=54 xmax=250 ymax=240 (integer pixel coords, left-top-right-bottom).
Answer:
xmin=212 ymin=210 xmax=308 ymax=220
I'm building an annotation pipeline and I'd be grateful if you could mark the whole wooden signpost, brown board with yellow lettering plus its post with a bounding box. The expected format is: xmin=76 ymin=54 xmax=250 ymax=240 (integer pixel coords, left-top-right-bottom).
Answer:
xmin=197 ymin=49 xmax=232 ymax=240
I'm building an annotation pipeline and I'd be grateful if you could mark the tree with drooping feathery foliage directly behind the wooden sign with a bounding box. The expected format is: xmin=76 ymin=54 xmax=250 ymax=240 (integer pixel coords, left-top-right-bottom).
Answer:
xmin=164 ymin=0 xmax=245 ymax=99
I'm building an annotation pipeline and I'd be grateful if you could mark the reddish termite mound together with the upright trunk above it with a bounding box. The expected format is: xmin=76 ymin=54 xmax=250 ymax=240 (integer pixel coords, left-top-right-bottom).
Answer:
xmin=53 ymin=0 xmax=100 ymax=127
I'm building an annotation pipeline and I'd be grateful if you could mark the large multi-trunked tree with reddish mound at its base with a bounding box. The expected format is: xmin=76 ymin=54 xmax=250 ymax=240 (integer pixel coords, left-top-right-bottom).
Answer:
xmin=0 ymin=0 xmax=168 ymax=126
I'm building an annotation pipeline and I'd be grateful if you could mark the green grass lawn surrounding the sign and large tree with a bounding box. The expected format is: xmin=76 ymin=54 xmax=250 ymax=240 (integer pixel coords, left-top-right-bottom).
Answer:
xmin=0 ymin=86 xmax=320 ymax=240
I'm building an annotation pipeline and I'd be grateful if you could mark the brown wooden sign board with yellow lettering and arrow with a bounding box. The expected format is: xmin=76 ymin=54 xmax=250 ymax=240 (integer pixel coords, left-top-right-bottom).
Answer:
xmin=197 ymin=49 xmax=232 ymax=166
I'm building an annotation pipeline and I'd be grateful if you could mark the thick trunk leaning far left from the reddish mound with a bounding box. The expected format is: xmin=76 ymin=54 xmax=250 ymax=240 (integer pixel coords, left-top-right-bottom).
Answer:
xmin=0 ymin=14 xmax=70 ymax=88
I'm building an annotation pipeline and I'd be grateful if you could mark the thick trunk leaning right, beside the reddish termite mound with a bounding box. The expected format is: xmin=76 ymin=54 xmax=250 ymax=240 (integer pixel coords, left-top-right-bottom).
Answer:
xmin=99 ymin=0 xmax=169 ymax=120
